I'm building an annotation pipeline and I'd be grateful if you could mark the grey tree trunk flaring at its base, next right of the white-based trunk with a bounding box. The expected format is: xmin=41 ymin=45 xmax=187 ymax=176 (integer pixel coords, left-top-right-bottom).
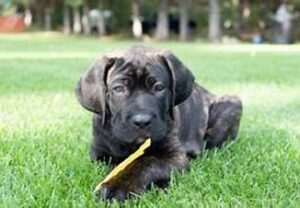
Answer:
xmin=155 ymin=0 xmax=169 ymax=40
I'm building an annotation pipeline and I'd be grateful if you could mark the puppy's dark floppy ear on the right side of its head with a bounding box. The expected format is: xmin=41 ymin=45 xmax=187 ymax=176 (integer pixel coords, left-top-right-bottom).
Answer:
xmin=162 ymin=51 xmax=195 ymax=106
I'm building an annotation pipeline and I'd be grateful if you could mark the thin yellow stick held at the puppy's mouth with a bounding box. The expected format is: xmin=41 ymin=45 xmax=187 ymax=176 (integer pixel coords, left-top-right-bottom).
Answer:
xmin=94 ymin=138 xmax=151 ymax=192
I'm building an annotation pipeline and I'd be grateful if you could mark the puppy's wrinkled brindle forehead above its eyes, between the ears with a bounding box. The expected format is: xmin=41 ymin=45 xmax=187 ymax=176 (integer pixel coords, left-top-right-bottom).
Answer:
xmin=107 ymin=57 xmax=170 ymax=84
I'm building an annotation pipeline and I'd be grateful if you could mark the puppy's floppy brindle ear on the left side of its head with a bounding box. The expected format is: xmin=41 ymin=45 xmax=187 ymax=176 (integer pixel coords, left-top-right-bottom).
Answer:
xmin=75 ymin=57 xmax=115 ymax=123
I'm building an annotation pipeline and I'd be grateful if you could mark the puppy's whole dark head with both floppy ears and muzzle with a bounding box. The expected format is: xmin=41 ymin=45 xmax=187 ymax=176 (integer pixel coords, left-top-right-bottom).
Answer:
xmin=76 ymin=47 xmax=194 ymax=143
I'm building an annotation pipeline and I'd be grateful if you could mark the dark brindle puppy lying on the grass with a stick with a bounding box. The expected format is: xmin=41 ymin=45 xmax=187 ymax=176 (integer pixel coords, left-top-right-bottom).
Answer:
xmin=76 ymin=47 xmax=242 ymax=201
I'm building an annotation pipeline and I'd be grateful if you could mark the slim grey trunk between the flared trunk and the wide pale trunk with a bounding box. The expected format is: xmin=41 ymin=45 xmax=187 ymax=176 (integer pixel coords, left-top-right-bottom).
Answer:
xmin=179 ymin=0 xmax=191 ymax=41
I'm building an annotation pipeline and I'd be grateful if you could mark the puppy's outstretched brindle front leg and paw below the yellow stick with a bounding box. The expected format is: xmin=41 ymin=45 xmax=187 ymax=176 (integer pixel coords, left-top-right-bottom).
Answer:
xmin=96 ymin=145 xmax=188 ymax=201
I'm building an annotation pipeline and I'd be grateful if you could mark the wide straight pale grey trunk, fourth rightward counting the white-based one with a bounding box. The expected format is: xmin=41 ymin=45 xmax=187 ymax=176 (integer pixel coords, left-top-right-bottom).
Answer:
xmin=208 ymin=0 xmax=221 ymax=43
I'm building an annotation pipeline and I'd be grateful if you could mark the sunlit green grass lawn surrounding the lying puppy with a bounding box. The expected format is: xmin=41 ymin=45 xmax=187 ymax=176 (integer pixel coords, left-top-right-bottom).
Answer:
xmin=0 ymin=34 xmax=300 ymax=207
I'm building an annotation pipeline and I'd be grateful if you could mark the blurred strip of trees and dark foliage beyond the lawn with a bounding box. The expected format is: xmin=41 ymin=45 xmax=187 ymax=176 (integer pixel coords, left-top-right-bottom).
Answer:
xmin=0 ymin=0 xmax=300 ymax=44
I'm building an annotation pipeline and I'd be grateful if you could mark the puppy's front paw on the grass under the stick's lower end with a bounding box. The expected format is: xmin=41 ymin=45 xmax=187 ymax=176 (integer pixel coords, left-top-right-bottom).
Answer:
xmin=94 ymin=181 xmax=141 ymax=202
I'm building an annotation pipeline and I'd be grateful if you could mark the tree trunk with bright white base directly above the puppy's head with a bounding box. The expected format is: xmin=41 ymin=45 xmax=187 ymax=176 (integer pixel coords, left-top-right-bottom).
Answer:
xmin=132 ymin=0 xmax=143 ymax=39
